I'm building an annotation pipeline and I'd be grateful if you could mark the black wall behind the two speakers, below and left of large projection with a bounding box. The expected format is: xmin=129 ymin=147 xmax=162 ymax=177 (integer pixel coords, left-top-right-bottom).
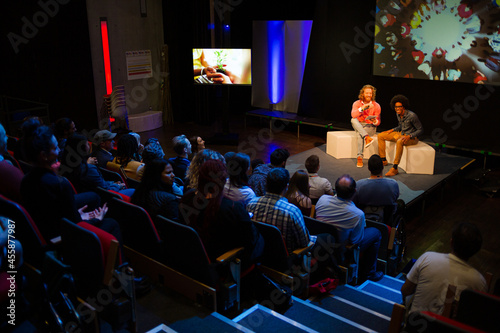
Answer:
xmin=299 ymin=0 xmax=500 ymax=153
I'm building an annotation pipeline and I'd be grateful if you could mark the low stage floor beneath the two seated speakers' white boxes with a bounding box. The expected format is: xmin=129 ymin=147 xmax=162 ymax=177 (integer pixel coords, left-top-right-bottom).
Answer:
xmin=286 ymin=145 xmax=474 ymax=206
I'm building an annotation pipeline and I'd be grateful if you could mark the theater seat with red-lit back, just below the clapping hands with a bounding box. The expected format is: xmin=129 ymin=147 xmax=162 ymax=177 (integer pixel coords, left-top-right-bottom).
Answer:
xmin=61 ymin=218 xmax=136 ymax=330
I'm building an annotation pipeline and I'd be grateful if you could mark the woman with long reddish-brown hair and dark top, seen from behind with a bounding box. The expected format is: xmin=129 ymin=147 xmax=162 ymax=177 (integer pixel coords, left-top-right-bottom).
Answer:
xmin=179 ymin=159 xmax=264 ymax=266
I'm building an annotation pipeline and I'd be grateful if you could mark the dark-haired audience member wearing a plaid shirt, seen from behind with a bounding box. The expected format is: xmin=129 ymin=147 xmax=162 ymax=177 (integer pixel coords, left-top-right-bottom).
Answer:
xmin=247 ymin=168 xmax=340 ymax=281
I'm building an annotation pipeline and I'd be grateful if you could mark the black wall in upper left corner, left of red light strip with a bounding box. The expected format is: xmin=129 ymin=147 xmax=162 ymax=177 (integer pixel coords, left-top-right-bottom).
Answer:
xmin=0 ymin=1 xmax=97 ymax=134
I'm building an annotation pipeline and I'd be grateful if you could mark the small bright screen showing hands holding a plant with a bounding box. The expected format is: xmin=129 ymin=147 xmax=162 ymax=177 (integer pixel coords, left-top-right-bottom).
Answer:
xmin=193 ymin=49 xmax=252 ymax=85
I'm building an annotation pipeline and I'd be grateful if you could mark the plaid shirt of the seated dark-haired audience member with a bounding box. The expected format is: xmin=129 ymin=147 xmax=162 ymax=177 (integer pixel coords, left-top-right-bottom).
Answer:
xmin=247 ymin=193 xmax=309 ymax=253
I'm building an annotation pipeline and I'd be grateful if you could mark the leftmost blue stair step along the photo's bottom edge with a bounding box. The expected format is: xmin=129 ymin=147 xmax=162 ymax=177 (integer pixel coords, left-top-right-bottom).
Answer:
xmin=169 ymin=312 xmax=253 ymax=333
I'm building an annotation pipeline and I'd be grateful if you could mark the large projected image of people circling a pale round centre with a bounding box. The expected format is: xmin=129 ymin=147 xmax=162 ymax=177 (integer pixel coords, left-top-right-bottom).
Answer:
xmin=373 ymin=0 xmax=500 ymax=84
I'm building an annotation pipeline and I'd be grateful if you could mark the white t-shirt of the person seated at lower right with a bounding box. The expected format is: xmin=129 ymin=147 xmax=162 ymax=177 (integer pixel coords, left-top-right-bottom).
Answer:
xmin=406 ymin=252 xmax=486 ymax=314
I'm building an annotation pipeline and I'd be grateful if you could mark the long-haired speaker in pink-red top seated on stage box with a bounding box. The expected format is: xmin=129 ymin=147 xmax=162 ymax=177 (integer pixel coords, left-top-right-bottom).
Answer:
xmin=351 ymin=84 xmax=381 ymax=168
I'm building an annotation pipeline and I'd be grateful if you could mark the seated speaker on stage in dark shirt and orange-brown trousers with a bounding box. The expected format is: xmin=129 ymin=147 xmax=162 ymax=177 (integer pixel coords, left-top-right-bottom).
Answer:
xmin=378 ymin=95 xmax=423 ymax=177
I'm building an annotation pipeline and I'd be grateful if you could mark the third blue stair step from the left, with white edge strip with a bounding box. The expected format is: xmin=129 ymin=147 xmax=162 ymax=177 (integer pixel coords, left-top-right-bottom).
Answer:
xmin=284 ymin=297 xmax=390 ymax=332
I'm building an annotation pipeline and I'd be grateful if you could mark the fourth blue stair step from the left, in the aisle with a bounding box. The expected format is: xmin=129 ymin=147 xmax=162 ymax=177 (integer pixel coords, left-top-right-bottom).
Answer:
xmin=322 ymin=285 xmax=394 ymax=317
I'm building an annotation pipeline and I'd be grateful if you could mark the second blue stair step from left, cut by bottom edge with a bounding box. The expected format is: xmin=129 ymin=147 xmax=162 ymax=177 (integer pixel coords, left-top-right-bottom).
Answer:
xmin=233 ymin=304 xmax=317 ymax=333
